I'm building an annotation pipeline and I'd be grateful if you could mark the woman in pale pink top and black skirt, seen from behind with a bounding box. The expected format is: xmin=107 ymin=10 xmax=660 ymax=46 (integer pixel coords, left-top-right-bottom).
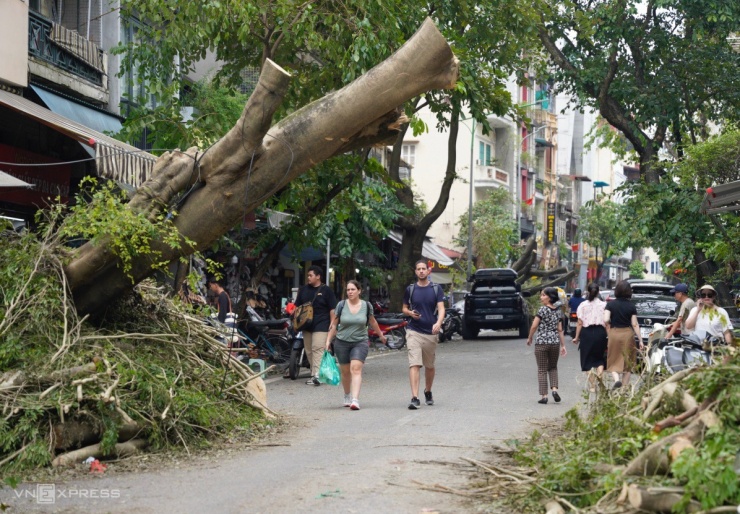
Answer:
xmin=573 ymin=282 xmax=607 ymax=393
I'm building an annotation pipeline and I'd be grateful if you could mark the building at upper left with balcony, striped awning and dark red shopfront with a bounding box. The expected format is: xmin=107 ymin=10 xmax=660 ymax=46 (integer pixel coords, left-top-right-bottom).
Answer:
xmin=0 ymin=0 xmax=154 ymax=224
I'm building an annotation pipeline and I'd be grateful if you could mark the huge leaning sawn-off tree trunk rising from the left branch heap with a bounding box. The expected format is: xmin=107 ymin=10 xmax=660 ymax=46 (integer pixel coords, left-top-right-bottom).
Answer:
xmin=65 ymin=19 xmax=458 ymax=313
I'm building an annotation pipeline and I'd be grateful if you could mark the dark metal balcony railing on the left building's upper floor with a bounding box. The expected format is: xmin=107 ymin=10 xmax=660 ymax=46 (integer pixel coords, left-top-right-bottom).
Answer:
xmin=28 ymin=11 xmax=105 ymax=86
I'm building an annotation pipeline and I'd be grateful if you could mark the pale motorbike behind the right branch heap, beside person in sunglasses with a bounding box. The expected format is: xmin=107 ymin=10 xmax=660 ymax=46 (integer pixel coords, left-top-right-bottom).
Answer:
xmin=644 ymin=323 xmax=725 ymax=375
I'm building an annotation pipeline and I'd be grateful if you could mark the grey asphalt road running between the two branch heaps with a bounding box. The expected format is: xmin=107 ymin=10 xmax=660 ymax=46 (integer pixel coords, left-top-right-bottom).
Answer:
xmin=0 ymin=332 xmax=583 ymax=514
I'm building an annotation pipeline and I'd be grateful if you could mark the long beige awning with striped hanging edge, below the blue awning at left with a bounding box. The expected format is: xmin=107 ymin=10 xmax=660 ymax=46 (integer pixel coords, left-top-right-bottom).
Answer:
xmin=0 ymin=90 xmax=157 ymax=187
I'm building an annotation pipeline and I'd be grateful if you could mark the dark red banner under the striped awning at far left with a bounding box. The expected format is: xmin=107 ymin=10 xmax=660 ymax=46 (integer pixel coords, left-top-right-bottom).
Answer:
xmin=0 ymin=144 xmax=72 ymax=207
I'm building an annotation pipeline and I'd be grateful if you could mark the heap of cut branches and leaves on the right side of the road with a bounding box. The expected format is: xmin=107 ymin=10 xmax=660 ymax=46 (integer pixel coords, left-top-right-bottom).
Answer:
xmin=469 ymin=348 xmax=740 ymax=514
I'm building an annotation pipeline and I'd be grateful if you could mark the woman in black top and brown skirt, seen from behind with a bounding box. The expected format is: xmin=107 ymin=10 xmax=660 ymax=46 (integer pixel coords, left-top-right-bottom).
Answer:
xmin=604 ymin=280 xmax=645 ymax=389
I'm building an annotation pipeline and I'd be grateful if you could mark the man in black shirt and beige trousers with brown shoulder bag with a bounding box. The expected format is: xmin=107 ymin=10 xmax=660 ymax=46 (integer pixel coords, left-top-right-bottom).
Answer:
xmin=295 ymin=266 xmax=337 ymax=386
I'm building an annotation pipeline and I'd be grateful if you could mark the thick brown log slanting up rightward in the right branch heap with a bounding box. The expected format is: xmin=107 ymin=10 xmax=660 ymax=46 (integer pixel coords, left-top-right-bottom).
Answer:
xmin=623 ymin=410 xmax=719 ymax=476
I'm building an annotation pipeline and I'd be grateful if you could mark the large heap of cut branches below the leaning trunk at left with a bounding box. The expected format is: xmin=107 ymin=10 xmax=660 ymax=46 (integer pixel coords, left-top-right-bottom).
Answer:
xmin=0 ymin=226 xmax=274 ymax=476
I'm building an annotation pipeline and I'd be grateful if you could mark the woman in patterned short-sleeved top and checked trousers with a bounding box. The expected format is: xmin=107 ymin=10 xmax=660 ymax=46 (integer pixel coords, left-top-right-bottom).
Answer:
xmin=527 ymin=287 xmax=568 ymax=404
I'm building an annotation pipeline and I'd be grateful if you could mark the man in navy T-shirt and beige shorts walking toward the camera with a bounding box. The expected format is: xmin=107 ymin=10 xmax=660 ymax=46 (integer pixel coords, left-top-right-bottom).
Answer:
xmin=403 ymin=259 xmax=445 ymax=410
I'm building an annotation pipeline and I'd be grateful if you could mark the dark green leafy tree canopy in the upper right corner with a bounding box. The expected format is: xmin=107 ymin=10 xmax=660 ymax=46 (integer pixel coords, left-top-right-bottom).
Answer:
xmin=540 ymin=0 xmax=740 ymax=182
